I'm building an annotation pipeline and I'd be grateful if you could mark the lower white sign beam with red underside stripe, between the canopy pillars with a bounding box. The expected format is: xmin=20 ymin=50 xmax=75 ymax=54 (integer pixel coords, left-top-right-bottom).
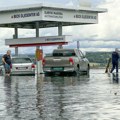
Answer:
xmin=5 ymin=36 xmax=71 ymax=47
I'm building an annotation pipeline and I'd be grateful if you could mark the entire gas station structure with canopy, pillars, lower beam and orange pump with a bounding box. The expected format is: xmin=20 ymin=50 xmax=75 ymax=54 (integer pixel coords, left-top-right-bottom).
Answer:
xmin=0 ymin=4 xmax=107 ymax=74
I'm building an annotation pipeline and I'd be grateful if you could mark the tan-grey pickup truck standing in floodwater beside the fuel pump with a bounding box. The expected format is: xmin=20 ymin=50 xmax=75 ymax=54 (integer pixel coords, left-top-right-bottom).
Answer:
xmin=43 ymin=49 xmax=90 ymax=74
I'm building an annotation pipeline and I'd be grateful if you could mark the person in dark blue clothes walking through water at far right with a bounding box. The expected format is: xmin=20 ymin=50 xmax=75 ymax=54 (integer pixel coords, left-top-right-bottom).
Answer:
xmin=110 ymin=48 xmax=119 ymax=73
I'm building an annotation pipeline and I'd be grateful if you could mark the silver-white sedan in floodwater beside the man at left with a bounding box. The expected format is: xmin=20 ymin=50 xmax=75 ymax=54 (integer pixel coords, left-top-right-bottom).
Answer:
xmin=0 ymin=56 xmax=35 ymax=75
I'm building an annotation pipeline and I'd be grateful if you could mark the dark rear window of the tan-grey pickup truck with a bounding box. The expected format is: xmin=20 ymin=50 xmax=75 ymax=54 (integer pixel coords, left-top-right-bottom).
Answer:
xmin=53 ymin=50 xmax=75 ymax=57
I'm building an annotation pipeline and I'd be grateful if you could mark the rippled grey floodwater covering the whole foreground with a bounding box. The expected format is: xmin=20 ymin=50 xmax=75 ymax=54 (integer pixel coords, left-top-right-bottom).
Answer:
xmin=0 ymin=70 xmax=120 ymax=120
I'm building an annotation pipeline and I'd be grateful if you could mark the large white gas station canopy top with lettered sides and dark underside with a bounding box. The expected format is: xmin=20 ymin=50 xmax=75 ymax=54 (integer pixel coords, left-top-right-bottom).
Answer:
xmin=0 ymin=4 xmax=107 ymax=29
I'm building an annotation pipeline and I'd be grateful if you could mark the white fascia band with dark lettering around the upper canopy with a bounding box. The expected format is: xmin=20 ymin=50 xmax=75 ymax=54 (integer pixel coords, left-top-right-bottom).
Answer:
xmin=0 ymin=8 xmax=98 ymax=24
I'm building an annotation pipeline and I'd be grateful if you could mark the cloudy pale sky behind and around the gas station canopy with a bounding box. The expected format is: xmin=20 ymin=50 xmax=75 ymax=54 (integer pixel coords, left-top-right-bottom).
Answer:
xmin=0 ymin=0 xmax=120 ymax=53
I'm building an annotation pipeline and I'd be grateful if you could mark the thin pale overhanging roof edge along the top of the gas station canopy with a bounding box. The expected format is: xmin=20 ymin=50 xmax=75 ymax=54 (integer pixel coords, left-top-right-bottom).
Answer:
xmin=0 ymin=3 xmax=107 ymax=13
